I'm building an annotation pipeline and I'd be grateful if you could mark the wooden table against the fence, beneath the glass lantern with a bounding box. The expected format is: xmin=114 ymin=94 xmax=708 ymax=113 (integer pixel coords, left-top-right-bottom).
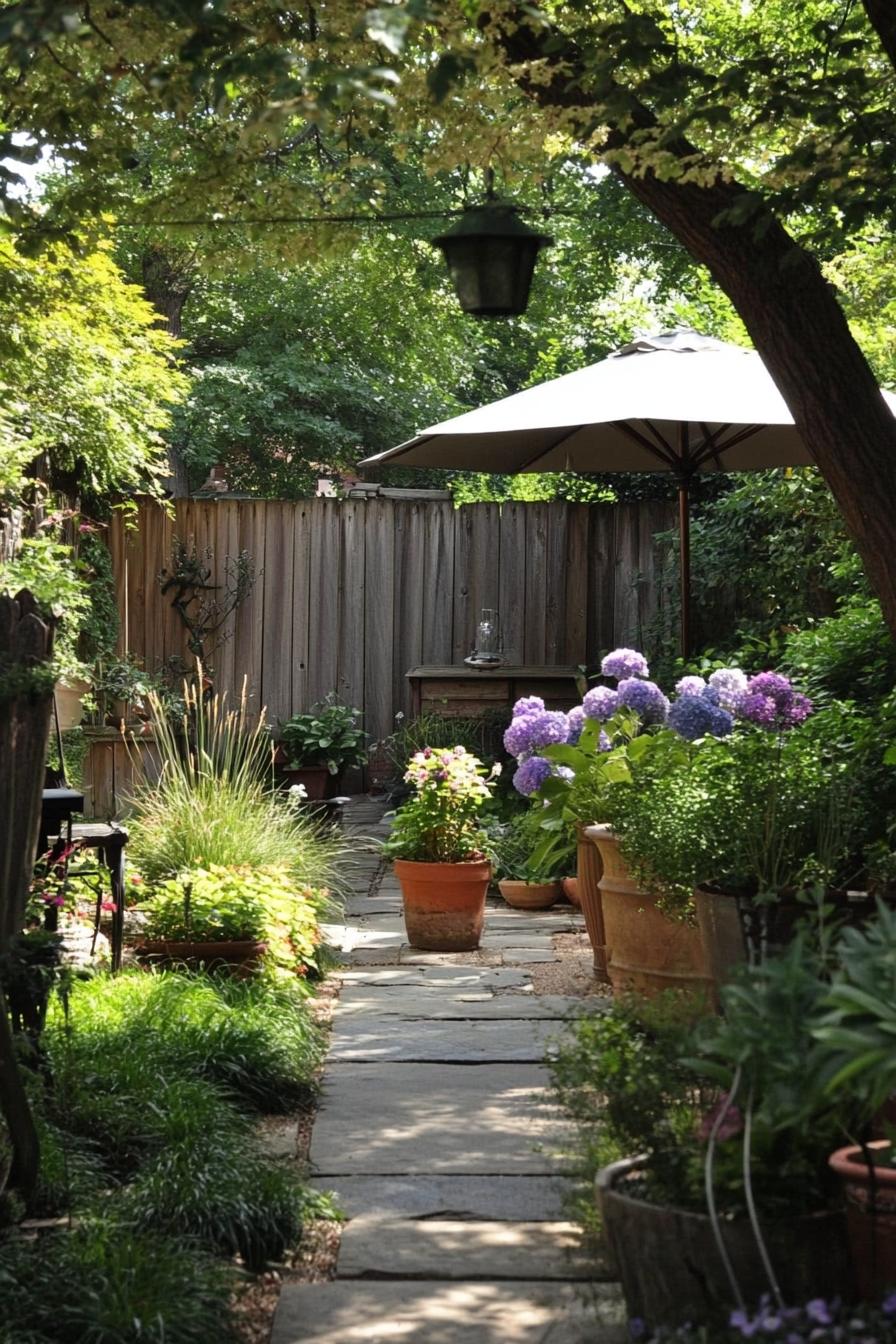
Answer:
xmin=406 ymin=663 xmax=587 ymax=719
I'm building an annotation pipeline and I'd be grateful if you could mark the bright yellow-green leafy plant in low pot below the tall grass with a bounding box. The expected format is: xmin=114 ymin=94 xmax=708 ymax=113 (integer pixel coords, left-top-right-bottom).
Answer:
xmin=141 ymin=864 xmax=326 ymax=974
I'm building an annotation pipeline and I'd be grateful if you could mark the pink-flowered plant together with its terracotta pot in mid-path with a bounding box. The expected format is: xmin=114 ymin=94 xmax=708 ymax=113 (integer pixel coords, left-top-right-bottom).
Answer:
xmin=383 ymin=746 xmax=496 ymax=952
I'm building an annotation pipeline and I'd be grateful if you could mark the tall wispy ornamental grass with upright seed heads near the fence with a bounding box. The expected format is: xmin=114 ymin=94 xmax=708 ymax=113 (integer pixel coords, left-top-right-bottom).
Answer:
xmin=129 ymin=685 xmax=351 ymax=892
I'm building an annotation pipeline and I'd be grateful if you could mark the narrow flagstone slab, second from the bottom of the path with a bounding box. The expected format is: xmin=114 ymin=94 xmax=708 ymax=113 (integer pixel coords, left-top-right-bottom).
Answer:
xmin=336 ymin=1218 xmax=609 ymax=1284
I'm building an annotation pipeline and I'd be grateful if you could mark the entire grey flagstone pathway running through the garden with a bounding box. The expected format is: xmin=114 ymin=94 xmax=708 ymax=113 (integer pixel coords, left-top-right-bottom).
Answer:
xmin=271 ymin=800 xmax=623 ymax=1344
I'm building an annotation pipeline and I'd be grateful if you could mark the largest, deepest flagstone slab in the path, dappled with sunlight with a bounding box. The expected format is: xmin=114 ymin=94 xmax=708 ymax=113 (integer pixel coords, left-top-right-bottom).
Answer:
xmin=310 ymin=1063 xmax=568 ymax=1176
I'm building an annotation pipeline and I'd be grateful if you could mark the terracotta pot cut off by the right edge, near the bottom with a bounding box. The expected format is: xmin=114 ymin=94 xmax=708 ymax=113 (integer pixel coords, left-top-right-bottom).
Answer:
xmin=829 ymin=1138 xmax=896 ymax=1302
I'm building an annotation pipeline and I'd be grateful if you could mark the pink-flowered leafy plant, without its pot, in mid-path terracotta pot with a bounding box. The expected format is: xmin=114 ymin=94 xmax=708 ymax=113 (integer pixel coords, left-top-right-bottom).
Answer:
xmin=383 ymin=746 xmax=500 ymax=863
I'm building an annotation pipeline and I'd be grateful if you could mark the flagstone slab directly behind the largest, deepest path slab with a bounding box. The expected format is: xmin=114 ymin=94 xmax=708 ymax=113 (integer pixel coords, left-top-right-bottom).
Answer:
xmin=329 ymin=1016 xmax=562 ymax=1064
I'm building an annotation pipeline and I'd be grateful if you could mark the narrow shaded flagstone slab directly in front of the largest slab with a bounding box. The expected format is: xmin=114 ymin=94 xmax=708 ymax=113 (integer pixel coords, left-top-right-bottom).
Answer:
xmin=312 ymin=1176 xmax=568 ymax=1236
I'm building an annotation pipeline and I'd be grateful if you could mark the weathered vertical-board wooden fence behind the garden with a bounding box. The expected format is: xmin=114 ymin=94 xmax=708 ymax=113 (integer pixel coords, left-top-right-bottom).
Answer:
xmin=110 ymin=499 xmax=674 ymax=739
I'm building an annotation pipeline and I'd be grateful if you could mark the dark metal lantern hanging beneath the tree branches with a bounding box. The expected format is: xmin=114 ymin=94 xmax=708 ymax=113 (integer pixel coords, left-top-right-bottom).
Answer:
xmin=433 ymin=198 xmax=553 ymax=317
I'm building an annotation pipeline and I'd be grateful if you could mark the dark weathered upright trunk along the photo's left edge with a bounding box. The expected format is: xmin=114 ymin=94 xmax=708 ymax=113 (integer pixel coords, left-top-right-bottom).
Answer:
xmin=0 ymin=593 xmax=54 ymax=1200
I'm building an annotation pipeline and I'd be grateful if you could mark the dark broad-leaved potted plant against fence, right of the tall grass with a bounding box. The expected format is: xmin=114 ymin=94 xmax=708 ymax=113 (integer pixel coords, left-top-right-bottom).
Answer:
xmin=279 ymin=692 xmax=367 ymax=800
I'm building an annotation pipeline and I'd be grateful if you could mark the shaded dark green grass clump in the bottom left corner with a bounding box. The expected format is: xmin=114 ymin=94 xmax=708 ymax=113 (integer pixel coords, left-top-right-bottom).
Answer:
xmin=0 ymin=1216 xmax=236 ymax=1344
